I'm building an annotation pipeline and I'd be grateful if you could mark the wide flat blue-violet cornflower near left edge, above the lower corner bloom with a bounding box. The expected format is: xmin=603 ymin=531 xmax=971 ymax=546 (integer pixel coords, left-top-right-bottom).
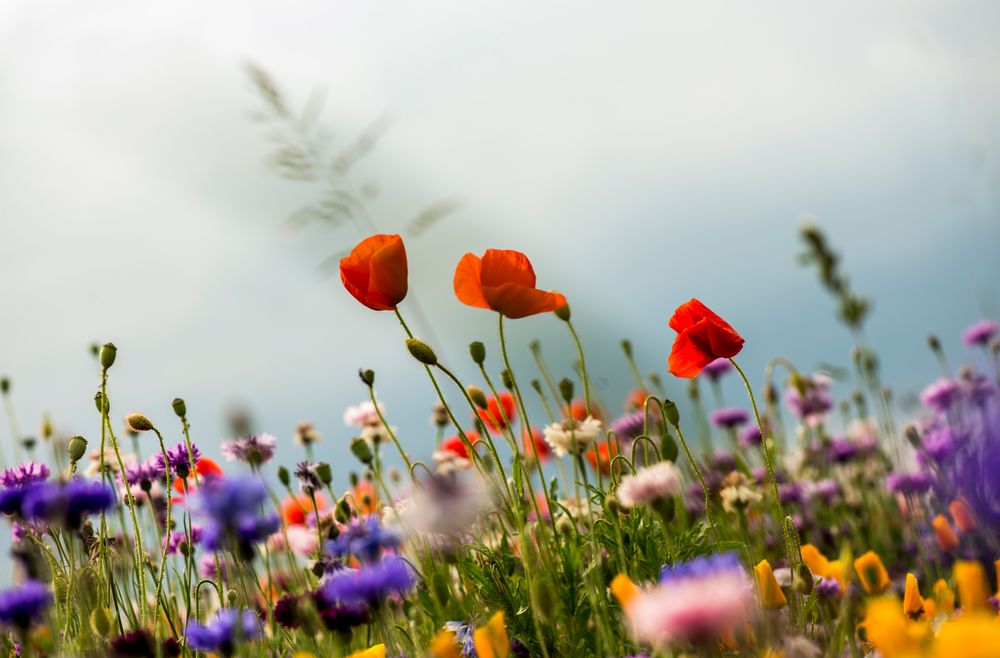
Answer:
xmin=21 ymin=479 xmax=115 ymax=530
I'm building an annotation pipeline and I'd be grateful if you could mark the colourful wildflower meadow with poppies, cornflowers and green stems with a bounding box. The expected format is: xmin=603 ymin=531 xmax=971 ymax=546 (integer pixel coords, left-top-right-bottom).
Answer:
xmin=0 ymin=220 xmax=1000 ymax=658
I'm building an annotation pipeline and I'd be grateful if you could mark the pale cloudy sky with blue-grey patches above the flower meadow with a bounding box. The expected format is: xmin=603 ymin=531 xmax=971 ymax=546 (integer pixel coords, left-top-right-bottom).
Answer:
xmin=0 ymin=0 xmax=1000 ymax=472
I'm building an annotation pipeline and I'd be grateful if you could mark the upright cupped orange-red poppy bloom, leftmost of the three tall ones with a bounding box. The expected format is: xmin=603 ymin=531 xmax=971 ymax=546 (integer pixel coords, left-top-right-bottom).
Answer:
xmin=340 ymin=235 xmax=407 ymax=311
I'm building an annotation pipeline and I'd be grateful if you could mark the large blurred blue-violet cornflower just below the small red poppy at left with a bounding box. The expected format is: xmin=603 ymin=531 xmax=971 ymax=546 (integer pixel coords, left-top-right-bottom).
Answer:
xmin=195 ymin=477 xmax=281 ymax=558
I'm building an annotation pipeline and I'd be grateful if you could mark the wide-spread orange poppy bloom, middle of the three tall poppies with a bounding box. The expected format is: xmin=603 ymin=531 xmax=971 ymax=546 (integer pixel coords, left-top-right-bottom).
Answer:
xmin=454 ymin=249 xmax=566 ymax=319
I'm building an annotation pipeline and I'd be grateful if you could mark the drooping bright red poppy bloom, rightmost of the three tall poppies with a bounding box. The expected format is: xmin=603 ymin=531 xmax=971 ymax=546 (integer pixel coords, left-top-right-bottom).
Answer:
xmin=669 ymin=299 xmax=743 ymax=379
